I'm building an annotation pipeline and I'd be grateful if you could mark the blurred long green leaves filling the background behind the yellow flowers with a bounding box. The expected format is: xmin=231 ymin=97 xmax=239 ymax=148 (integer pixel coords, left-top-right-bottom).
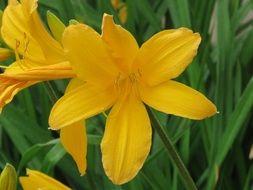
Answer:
xmin=0 ymin=0 xmax=253 ymax=190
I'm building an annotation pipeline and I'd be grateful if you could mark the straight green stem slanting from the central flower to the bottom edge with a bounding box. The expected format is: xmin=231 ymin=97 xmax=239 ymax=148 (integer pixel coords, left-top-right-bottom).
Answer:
xmin=147 ymin=108 xmax=197 ymax=190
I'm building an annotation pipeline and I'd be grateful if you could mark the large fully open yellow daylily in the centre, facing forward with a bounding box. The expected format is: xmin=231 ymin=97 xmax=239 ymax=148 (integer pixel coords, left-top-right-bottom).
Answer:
xmin=49 ymin=15 xmax=217 ymax=184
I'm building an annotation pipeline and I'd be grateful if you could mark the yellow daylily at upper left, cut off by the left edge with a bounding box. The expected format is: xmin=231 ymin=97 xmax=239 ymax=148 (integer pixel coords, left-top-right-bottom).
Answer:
xmin=0 ymin=0 xmax=75 ymax=110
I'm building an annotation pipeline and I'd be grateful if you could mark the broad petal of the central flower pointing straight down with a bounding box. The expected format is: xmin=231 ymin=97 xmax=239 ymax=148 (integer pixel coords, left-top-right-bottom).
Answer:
xmin=101 ymin=91 xmax=152 ymax=184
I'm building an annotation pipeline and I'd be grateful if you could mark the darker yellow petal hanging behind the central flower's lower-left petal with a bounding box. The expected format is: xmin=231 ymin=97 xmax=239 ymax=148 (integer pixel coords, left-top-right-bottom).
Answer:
xmin=60 ymin=121 xmax=87 ymax=175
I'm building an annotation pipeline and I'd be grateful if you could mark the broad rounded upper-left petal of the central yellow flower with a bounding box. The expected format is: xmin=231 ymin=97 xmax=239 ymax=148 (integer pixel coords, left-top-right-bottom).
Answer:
xmin=63 ymin=24 xmax=119 ymax=86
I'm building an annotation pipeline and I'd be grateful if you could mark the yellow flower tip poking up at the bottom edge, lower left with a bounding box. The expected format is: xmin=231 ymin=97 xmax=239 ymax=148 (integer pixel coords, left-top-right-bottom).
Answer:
xmin=19 ymin=169 xmax=70 ymax=190
